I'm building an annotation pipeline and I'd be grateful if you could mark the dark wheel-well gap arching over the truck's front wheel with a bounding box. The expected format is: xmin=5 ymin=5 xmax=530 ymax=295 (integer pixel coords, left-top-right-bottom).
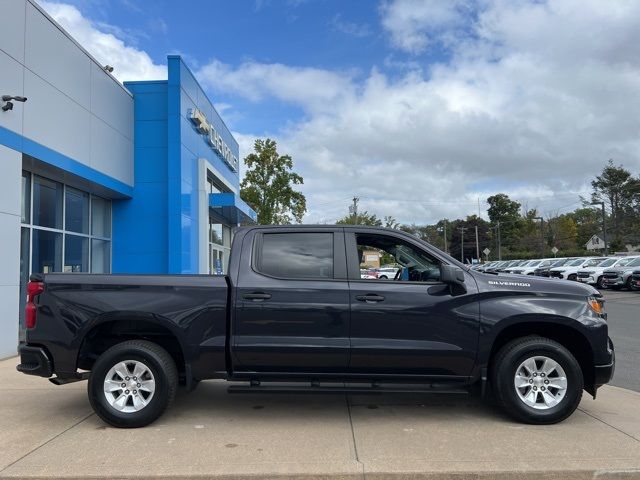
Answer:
xmin=489 ymin=322 xmax=594 ymax=389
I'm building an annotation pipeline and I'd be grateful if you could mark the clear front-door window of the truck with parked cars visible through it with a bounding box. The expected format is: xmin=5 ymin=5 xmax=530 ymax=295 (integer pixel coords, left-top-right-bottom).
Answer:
xmin=356 ymin=234 xmax=440 ymax=283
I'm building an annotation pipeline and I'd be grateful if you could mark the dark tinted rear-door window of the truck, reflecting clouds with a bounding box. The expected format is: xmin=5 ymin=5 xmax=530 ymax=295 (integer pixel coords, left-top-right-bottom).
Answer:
xmin=258 ymin=233 xmax=333 ymax=278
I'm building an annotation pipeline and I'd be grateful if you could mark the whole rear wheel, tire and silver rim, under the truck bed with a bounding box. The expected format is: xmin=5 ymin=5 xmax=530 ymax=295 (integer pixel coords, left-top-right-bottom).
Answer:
xmin=88 ymin=340 xmax=178 ymax=428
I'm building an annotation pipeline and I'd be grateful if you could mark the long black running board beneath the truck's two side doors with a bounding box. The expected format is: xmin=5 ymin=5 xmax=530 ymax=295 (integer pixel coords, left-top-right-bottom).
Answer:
xmin=227 ymin=381 xmax=469 ymax=395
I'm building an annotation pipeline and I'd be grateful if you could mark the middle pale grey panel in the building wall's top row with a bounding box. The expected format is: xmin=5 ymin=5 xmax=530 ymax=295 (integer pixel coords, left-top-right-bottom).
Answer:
xmin=24 ymin=3 xmax=91 ymax=110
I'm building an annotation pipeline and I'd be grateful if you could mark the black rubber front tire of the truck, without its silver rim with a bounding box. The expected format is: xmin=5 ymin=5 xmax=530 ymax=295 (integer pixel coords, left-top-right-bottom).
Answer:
xmin=491 ymin=336 xmax=584 ymax=425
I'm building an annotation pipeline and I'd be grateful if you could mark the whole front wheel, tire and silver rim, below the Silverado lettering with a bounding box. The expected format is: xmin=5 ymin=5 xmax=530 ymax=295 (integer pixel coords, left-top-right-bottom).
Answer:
xmin=491 ymin=337 xmax=584 ymax=424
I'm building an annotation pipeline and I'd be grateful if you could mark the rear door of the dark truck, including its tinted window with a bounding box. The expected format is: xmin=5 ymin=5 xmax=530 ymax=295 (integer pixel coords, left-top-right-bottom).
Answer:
xmin=231 ymin=227 xmax=349 ymax=373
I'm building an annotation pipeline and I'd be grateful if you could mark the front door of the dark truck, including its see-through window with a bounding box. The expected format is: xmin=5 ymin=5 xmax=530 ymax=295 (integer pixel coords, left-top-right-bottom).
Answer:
xmin=346 ymin=229 xmax=479 ymax=378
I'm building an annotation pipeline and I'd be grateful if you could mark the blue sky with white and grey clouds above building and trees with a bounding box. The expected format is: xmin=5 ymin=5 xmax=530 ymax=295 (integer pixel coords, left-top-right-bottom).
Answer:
xmin=40 ymin=0 xmax=640 ymax=224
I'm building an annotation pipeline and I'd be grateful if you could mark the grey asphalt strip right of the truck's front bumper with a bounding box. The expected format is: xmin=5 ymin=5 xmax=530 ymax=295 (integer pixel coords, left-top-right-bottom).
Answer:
xmin=602 ymin=290 xmax=640 ymax=392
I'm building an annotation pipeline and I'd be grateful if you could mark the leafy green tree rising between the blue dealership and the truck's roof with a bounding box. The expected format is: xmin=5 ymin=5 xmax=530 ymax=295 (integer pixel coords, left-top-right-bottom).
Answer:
xmin=240 ymin=138 xmax=307 ymax=225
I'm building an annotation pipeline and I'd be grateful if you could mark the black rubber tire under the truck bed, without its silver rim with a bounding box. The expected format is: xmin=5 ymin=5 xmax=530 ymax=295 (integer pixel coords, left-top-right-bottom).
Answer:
xmin=87 ymin=340 xmax=178 ymax=428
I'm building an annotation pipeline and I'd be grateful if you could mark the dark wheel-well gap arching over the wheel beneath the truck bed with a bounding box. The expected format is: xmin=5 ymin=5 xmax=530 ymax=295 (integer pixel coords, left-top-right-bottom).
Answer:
xmin=77 ymin=319 xmax=185 ymax=374
